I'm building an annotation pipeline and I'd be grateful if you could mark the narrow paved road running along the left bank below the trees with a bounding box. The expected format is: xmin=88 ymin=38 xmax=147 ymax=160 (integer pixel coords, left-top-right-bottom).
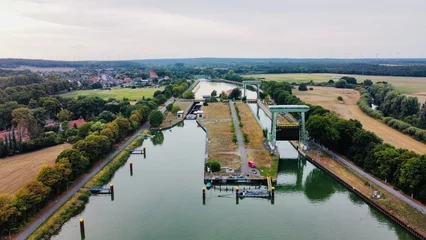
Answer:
xmin=17 ymin=98 xmax=174 ymax=240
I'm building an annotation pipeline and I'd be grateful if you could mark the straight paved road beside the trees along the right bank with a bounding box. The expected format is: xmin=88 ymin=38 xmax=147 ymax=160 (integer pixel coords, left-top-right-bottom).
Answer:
xmin=311 ymin=142 xmax=426 ymax=214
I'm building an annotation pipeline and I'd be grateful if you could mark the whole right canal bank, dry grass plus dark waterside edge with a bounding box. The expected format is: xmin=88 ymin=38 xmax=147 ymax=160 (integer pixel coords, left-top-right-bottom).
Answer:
xmin=292 ymin=142 xmax=426 ymax=239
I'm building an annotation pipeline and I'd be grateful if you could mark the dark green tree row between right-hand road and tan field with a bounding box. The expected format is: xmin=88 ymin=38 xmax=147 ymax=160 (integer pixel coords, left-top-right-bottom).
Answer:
xmin=262 ymin=81 xmax=426 ymax=203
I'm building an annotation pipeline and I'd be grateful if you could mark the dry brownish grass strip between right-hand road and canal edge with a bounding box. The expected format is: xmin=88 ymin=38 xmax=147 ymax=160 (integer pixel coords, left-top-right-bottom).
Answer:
xmin=308 ymin=151 xmax=426 ymax=235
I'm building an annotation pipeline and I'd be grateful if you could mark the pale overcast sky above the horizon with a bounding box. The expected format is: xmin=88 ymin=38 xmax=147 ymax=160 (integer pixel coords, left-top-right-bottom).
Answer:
xmin=0 ymin=0 xmax=426 ymax=60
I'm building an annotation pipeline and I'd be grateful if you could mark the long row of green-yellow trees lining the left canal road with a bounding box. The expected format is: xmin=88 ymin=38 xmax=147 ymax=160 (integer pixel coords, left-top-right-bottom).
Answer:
xmin=0 ymin=86 xmax=176 ymax=229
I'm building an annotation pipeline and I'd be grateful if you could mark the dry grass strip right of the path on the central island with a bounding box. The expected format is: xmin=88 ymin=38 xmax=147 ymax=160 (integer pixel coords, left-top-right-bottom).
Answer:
xmin=237 ymin=102 xmax=278 ymax=178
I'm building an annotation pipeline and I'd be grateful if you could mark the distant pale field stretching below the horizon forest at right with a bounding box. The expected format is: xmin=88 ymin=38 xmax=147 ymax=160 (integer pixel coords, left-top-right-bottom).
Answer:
xmin=244 ymin=73 xmax=426 ymax=95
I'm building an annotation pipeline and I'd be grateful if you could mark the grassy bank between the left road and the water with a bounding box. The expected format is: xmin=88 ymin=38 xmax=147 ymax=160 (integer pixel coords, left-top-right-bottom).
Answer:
xmin=27 ymin=137 xmax=143 ymax=240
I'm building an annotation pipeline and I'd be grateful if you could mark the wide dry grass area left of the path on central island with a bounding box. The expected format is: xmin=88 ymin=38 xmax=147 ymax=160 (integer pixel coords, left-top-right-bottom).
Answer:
xmin=201 ymin=102 xmax=241 ymax=169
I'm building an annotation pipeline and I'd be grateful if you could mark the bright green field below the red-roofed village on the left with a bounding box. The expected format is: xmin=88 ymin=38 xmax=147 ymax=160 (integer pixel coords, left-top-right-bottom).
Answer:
xmin=60 ymin=87 xmax=164 ymax=101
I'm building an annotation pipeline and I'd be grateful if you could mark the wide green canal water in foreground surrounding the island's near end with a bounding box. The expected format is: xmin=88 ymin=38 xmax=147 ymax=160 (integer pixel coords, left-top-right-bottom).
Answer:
xmin=53 ymin=83 xmax=415 ymax=240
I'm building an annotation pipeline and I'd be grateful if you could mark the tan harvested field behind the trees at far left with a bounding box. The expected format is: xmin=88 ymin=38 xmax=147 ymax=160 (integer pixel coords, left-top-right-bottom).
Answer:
xmin=0 ymin=143 xmax=71 ymax=194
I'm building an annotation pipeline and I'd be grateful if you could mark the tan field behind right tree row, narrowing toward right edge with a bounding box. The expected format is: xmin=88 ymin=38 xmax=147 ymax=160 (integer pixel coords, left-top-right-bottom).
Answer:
xmin=293 ymin=87 xmax=426 ymax=154
